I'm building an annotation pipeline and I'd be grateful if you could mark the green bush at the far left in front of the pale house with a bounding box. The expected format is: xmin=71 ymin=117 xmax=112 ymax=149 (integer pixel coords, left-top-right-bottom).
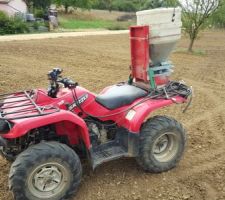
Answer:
xmin=0 ymin=11 xmax=29 ymax=35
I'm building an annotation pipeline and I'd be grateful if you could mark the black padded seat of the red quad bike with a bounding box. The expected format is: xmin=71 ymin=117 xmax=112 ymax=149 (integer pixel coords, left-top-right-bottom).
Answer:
xmin=96 ymin=84 xmax=148 ymax=110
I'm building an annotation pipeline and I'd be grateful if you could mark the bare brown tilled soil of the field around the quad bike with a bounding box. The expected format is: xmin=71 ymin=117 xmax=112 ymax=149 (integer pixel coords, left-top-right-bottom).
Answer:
xmin=0 ymin=32 xmax=225 ymax=200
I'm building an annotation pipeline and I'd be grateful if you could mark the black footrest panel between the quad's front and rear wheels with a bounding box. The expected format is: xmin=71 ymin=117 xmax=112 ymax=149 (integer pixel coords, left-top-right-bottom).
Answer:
xmin=91 ymin=143 xmax=127 ymax=169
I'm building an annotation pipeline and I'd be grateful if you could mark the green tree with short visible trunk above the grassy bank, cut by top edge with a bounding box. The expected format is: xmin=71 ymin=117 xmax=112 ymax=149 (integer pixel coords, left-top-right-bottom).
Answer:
xmin=55 ymin=0 xmax=94 ymax=13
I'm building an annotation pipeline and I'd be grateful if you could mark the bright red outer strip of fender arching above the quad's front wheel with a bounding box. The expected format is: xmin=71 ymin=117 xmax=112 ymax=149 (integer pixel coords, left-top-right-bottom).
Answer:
xmin=2 ymin=110 xmax=90 ymax=149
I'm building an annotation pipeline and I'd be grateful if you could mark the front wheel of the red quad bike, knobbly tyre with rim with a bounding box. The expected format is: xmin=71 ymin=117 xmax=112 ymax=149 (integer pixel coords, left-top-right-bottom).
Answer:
xmin=9 ymin=142 xmax=82 ymax=200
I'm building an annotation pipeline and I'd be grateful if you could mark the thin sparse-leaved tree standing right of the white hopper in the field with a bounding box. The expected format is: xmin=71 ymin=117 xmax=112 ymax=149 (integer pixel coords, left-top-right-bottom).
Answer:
xmin=180 ymin=0 xmax=221 ymax=52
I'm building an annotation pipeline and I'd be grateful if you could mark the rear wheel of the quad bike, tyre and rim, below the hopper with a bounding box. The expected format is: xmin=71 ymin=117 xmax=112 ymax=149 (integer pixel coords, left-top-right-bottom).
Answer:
xmin=137 ymin=116 xmax=186 ymax=173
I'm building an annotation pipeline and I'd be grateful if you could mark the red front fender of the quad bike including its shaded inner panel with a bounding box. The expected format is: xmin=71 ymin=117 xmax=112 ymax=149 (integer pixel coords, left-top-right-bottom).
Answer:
xmin=2 ymin=110 xmax=90 ymax=149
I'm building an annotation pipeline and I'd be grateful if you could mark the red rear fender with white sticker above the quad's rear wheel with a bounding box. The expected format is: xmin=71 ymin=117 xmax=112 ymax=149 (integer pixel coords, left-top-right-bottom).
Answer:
xmin=124 ymin=97 xmax=186 ymax=133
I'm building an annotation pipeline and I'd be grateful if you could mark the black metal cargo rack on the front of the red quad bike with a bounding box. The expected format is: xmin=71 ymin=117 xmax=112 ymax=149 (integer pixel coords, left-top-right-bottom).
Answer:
xmin=0 ymin=90 xmax=60 ymax=120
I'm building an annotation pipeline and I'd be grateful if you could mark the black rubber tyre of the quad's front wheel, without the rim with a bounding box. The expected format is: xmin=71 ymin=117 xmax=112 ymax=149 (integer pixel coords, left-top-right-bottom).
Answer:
xmin=9 ymin=142 xmax=82 ymax=200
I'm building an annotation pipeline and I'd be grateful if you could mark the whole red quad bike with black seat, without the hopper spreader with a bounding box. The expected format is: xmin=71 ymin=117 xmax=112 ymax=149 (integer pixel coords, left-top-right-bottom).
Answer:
xmin=0 ymin=27 xmax=191 ymax=200
